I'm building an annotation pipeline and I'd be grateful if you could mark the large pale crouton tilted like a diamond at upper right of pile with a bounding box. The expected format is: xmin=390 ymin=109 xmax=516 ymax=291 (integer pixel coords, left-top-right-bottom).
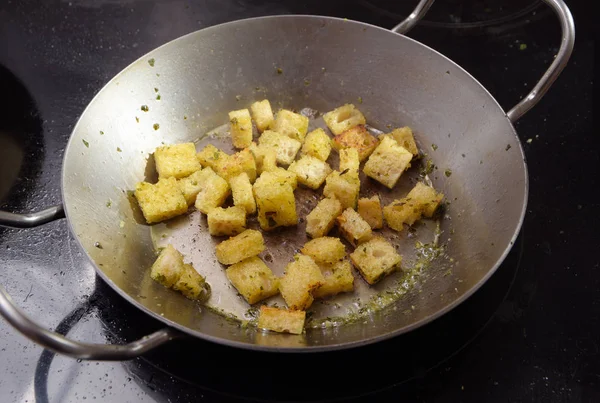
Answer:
xmin=363 ymin=137 xmax=412 ymax=189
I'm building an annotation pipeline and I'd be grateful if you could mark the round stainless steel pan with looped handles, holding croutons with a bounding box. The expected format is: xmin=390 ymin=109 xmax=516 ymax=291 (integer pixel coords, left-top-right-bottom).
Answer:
xmin=0 ymin=0 xmax=574 ymax=360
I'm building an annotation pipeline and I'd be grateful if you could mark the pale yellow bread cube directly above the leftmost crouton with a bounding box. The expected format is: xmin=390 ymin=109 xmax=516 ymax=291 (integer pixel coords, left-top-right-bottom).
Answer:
xmin=154 ymin=143 xmax=202 ymax=179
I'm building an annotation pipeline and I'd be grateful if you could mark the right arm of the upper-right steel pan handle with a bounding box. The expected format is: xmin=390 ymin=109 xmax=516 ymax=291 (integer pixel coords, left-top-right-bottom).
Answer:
xmin=506 ymin=0 xmax=575 ymax=123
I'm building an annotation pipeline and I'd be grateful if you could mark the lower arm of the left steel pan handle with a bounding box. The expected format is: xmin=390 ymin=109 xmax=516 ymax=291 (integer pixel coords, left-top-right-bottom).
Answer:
xmin=0 ymin=286 xmax=181 ymax=361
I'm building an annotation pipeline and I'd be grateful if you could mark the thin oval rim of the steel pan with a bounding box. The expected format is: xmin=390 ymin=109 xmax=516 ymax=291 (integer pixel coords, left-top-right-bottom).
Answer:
xmin=61 ymin=14 xmax=529 ymax=353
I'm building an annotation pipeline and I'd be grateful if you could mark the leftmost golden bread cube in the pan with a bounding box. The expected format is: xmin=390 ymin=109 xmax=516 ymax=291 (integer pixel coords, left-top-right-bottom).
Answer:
xmin=135 ymin=177 xmax=188 ymax=224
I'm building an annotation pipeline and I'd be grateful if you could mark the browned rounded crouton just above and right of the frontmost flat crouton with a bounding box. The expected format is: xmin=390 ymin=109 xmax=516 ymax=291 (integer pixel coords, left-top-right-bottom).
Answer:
xmin=279 ymin=254 xmax=325 ymax=311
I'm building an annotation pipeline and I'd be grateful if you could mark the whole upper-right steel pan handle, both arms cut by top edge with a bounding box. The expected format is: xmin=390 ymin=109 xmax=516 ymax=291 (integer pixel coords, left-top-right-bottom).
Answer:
xmin=392 ymin=0 xmax=575 ymax=123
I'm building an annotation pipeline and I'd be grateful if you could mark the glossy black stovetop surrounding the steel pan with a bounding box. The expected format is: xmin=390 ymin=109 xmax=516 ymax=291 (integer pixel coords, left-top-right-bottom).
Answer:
xmin=0 ymin=0 xmax=600 ymax=402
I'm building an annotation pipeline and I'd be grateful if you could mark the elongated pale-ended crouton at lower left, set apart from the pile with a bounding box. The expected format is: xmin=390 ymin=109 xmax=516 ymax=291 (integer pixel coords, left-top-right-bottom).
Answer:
xmin=150 ymin=244 xmax=209 ymax=300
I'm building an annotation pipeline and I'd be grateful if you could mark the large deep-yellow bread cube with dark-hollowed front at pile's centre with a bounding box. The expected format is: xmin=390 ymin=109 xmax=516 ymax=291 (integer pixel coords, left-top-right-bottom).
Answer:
xmin=253 ymin=179 xmax=298 ymax=231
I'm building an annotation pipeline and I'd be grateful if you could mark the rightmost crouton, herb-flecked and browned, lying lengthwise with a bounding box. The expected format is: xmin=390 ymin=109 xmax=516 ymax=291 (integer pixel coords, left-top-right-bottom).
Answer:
xmin=383 ymin=182 xmax=444 ymax=231
